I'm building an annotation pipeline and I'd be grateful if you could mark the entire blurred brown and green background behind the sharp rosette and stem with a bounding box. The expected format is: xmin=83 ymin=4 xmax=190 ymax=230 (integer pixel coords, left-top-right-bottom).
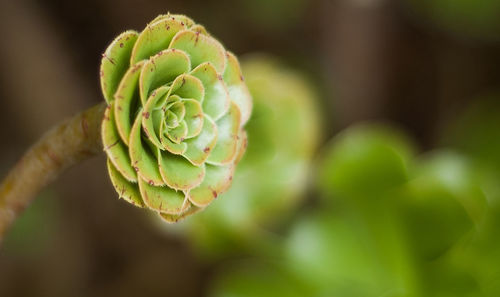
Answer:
xmin=0 ymin=0 xmax=500 ymax=297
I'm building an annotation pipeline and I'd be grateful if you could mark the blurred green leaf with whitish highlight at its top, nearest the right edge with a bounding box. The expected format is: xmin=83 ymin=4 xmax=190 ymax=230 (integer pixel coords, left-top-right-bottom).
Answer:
xmin=401 ymin=151 xmax=486 ymax=259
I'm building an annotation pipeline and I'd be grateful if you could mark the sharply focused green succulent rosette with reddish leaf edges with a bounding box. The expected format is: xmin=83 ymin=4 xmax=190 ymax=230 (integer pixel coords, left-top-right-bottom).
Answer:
xmin=100 ymin=14 xmax=252 ymax=222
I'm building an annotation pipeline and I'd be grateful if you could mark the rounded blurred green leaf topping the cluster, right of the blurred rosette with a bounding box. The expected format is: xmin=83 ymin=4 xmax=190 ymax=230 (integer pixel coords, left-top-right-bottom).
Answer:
xmin=319 ymin=124 xmax=414 ymax=199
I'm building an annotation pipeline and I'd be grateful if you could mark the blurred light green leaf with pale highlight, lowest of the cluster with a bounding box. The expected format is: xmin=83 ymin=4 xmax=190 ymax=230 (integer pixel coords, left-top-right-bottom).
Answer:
xmin=286 ymin=211 xmax=414 ymax=296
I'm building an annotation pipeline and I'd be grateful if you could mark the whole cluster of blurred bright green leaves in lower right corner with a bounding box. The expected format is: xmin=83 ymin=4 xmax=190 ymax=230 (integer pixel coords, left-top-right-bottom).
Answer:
xmin=213 ymin=124 xmax=500 ymax=297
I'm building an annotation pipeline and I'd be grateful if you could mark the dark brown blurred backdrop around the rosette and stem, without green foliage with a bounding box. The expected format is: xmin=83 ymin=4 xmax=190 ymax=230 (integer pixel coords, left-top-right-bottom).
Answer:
xmin=0 ymin=0 xmax=500 ymax=297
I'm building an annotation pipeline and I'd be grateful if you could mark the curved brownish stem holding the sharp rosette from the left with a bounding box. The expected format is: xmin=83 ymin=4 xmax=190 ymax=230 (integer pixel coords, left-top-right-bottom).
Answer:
xmin=0 ymin=102 xmax=106 ymax=241
